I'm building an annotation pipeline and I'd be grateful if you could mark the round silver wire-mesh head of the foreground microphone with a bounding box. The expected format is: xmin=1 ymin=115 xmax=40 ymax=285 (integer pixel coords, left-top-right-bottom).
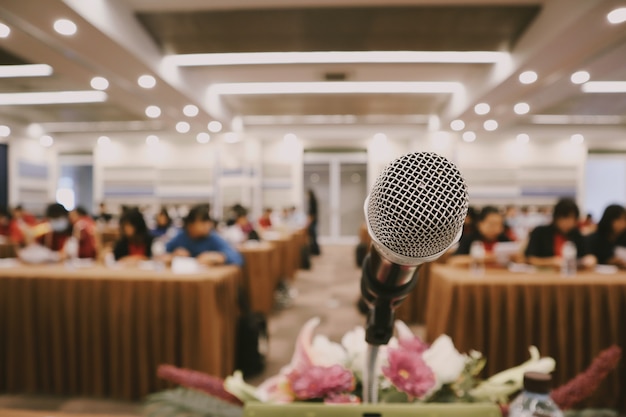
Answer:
xmin=366 ymin=152 xmax=468 ymax=258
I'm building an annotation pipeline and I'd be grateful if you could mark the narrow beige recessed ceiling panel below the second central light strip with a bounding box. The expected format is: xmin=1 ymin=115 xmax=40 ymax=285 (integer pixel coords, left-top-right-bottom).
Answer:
xmin=223 ymin=94 xmax=448 ymax=116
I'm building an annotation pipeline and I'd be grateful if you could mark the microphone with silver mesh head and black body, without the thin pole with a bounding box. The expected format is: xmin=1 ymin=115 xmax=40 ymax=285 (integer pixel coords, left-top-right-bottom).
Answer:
xmin=361 ymin=152 xmax=468 ymax=346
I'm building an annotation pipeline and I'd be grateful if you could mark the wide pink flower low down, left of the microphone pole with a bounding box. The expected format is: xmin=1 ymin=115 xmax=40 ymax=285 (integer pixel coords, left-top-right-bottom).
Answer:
xmin=287 ymin=365 xmax=354 ymax=400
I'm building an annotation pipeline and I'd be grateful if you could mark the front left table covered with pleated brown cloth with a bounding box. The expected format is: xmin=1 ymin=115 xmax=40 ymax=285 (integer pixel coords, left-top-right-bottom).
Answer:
xmin=0 ymin=265 xmax=241 ymax=399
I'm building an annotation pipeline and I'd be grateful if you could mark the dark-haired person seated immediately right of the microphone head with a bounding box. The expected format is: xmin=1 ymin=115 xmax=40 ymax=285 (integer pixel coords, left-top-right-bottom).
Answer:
xmin=448 ymin=206 xmax=511 ymax=265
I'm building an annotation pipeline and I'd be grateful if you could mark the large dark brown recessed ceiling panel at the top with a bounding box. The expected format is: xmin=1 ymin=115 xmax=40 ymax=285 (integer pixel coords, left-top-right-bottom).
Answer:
xmin=137 ymin=5 xmax=540 ymax=53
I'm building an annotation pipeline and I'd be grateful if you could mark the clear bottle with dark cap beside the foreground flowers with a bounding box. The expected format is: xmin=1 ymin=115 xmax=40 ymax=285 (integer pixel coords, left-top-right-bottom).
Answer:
xmin=509 ymin=372 xmax=563 ymax=417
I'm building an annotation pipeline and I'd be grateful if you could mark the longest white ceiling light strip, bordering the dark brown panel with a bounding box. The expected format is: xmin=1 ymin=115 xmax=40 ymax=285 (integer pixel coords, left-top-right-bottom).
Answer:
xmin=164 ymin=51 xmax=510 ymax=67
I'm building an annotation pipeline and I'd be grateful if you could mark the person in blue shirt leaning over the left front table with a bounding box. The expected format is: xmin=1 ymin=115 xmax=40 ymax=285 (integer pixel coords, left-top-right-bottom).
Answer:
xmin=165 ymin=205 xmax=243 ymax=266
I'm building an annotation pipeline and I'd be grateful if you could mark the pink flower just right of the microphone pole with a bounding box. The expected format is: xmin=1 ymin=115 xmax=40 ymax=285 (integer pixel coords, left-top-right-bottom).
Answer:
xmin=383 ymin=349 xmax=435 ymax=398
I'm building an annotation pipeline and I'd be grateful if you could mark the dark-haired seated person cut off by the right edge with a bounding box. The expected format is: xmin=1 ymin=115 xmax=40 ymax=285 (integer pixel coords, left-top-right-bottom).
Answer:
xmin=587 ymin=204 xmax=626 ymax=268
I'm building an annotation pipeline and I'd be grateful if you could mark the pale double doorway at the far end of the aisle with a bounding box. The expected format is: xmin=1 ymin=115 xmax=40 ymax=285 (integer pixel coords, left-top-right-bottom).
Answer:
xmin=303 ymin=151 xmax=367 ymax=244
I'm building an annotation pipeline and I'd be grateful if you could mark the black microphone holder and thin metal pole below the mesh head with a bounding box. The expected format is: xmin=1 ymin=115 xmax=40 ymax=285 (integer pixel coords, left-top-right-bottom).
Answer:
xmin=361 ymin=250 xmax=419 ymax=404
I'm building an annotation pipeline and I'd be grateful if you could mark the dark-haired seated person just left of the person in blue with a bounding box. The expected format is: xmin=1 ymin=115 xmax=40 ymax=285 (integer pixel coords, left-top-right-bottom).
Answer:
xmin=113 ymin=209 xmax=153 ymax=263
